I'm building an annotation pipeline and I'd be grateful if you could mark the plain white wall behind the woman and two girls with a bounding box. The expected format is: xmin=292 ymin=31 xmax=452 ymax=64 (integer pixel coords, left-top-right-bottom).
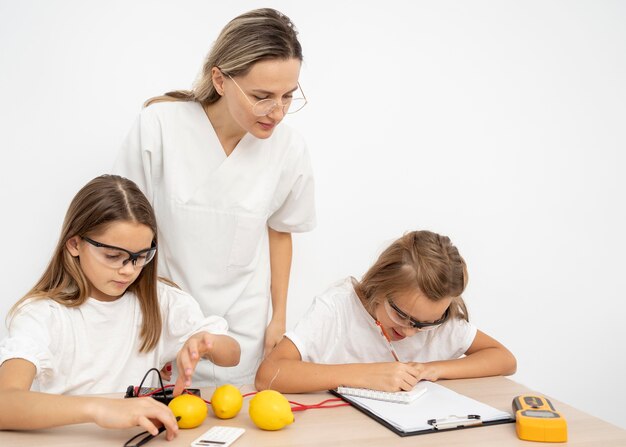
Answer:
xmin=0 ymin=0 xmax=626 ymax=428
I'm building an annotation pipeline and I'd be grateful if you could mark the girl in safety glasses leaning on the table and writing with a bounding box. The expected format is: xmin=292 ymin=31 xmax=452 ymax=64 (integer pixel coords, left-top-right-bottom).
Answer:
xmin=256 ymin=231 xmax=516 ymax=393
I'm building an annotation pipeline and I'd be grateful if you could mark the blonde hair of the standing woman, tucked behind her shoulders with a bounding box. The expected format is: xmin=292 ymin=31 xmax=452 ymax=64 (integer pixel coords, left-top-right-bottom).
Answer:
xmin=144 ymin=8 xmax=302 ymax=107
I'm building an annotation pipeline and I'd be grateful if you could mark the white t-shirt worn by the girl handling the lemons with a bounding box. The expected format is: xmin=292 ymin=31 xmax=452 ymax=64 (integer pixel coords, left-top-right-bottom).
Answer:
xmin=0 ymin=283 xmax=228 ymax=394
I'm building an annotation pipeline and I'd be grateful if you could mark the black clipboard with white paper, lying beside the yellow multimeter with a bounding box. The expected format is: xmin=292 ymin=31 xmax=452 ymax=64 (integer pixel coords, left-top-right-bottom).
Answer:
xmin=329 ymin=382 xmax=515 ymax=437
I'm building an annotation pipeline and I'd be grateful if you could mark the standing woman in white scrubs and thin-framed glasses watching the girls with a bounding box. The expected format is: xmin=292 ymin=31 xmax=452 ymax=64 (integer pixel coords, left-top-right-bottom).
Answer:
xmin=115 ymin=9 xmax=315 ymax=383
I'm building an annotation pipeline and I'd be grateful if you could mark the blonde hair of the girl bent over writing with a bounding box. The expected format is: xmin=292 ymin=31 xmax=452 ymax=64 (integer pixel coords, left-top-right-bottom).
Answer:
xmin=353 ymin=231 xmax=469 ymax=321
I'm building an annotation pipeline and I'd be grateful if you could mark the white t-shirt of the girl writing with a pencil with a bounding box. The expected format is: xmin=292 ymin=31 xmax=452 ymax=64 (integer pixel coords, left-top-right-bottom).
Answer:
xmin=285 ymin=278 xmax=476 ymax=364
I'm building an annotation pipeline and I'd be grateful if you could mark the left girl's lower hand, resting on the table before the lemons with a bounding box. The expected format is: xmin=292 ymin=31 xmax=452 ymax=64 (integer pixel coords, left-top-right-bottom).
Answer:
xmin=87 ymin=397 xmax=178 ymax=441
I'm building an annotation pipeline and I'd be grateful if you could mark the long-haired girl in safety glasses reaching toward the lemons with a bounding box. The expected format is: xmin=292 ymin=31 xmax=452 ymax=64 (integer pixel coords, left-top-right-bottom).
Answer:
xmin=0 ymin=176 xmax=240 ymax=439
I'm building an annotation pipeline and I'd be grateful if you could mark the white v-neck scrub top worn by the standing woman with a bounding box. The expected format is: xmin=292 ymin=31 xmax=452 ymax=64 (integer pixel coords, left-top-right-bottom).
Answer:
xmin=114 ymin=102 xmax=315 ymax=385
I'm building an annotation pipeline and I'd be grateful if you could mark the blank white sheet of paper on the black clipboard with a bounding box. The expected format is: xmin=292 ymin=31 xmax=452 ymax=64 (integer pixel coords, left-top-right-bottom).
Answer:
xmin=338 ymin=382 xmax=512 ymax=432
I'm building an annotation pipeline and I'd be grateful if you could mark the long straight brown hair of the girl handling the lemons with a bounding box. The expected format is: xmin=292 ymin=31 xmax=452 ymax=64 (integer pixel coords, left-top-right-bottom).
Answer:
xmin=9 ymin=175 xmax=162 ymax=352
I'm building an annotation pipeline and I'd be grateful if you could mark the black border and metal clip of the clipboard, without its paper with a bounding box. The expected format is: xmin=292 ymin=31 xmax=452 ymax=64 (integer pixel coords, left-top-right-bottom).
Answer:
xmin=328 ymin=390 xmax=515 ymax=437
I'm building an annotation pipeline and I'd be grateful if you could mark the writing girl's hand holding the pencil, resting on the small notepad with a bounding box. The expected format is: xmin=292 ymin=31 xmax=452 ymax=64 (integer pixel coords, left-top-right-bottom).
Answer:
xmin=359 ymin=362 xmax=423 ymax=392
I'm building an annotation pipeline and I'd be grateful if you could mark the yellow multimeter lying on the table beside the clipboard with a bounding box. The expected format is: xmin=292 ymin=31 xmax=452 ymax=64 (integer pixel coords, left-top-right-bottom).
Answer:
xmin=513 ymin=395 xmax=567 ymax=442
